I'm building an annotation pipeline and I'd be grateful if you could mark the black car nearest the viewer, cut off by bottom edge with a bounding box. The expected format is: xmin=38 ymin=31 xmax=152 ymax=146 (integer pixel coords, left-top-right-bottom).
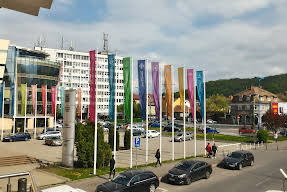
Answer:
xmin=96 ymin=169 xmax=159 ymax=192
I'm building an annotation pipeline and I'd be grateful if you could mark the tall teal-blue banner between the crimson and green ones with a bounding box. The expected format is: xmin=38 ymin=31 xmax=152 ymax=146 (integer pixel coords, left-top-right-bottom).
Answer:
xmin=108 ymin=55 xmax=115 ymax=120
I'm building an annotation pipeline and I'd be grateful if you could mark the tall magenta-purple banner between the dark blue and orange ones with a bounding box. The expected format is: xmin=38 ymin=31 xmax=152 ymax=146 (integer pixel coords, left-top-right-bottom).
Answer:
xmin=151 ymin=62 xmax=160 ymax=120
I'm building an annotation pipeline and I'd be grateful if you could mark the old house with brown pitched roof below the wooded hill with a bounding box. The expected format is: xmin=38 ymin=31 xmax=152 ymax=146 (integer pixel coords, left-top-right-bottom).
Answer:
xmin=230 ymin=86 xmax=280 ymax=125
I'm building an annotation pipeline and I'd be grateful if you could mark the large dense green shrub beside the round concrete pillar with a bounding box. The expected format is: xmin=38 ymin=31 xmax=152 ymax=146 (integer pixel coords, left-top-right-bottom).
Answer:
xmin=75 ymin=122 xmax=112 ymax=168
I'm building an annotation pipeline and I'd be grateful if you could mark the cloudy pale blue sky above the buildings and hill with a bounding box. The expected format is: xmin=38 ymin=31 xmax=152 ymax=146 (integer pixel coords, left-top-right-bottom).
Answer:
xmin=0 ymin=0 xmax=287 ymax=80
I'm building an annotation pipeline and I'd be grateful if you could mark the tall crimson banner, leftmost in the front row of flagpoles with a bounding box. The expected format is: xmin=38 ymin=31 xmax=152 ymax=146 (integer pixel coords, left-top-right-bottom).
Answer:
xmin=89 ymin=50 xmax=96 ymax=122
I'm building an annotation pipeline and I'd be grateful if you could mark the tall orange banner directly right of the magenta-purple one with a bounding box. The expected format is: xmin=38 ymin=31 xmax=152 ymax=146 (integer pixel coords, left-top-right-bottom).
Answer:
xmin=164 ymin=65 xmax=172 ymax=119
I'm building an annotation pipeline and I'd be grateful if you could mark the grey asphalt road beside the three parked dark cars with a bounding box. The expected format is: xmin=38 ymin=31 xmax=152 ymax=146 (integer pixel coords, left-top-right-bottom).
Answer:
xmin=160 ymin=150 xmax=287 ymax=192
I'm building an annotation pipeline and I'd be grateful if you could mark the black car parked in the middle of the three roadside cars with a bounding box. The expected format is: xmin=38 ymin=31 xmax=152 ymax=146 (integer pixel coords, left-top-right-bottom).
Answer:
xmin=167 ymin=160 xmax=212 ymax=185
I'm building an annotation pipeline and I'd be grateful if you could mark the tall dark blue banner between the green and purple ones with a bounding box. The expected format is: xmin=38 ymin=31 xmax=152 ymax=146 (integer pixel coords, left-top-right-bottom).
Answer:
xmin=138 ymin=60 xmax=146 ymax=120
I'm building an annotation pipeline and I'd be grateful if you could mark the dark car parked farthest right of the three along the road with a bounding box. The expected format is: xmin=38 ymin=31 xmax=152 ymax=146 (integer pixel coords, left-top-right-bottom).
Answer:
xmin=222 ymin=151 xmax=254 ymax=170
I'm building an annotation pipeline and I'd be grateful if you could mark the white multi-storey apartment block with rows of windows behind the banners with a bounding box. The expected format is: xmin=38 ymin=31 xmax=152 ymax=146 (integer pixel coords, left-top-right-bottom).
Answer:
xmin=35 ymin=47 xmax=124 ymax=116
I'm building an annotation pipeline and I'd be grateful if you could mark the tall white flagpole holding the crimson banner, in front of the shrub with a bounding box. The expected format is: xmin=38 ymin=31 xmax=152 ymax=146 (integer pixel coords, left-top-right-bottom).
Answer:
xmin=95 ymin=49 xmax=98 ymax=175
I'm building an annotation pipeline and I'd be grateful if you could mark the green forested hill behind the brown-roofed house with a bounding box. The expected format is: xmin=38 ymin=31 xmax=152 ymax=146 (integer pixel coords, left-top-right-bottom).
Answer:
xmin=206 ymin=74 xmax=287 ymax=97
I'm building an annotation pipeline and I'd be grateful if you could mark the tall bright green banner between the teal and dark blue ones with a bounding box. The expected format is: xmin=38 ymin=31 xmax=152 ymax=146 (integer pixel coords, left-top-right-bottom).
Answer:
xmin=123 ymin=57 xmax=131 ymax=122
